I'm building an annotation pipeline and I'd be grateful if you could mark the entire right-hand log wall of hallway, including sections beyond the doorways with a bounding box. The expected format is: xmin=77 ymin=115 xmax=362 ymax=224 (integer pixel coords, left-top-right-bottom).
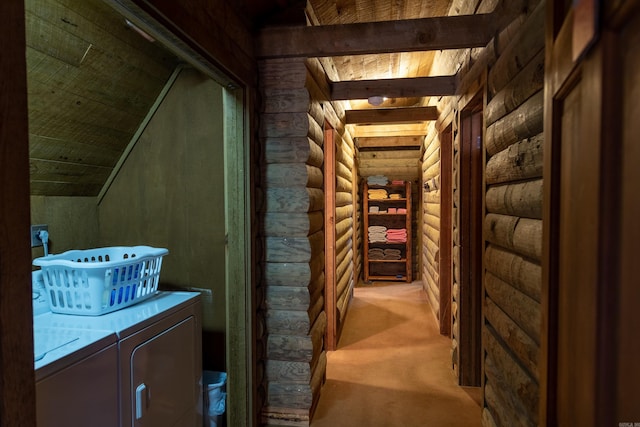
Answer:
xmin=422 ymin=0 xmax=545 ymax=426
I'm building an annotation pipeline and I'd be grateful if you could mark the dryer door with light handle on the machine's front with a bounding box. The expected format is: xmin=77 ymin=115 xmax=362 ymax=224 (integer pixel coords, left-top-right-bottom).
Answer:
xmin=130 ymin=317 xmax=200 ymax=427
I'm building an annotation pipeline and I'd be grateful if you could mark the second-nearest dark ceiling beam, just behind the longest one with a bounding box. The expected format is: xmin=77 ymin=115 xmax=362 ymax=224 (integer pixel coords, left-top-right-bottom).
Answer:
xmin=331 ymin=75 xmax=458 ymax=101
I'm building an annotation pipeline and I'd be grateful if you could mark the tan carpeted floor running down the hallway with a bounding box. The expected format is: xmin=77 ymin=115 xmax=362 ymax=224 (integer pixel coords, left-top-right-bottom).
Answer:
xmin=311 ymin=282 xmax=481 ymax=427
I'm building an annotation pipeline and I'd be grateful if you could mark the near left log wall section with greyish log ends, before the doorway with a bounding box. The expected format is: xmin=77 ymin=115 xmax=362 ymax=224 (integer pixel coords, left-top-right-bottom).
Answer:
xmin=258 ymin=59 xmax=327 ymax=425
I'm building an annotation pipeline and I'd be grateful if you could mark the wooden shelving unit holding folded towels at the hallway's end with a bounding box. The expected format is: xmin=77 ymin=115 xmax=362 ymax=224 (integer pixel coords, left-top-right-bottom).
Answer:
xmin=363 ymin=182 xmax=412 ymax=282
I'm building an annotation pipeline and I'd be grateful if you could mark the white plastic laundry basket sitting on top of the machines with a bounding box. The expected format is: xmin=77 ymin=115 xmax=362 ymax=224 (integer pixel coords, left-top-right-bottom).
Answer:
xmin=33 ymin=246 xmax=169 ymax=316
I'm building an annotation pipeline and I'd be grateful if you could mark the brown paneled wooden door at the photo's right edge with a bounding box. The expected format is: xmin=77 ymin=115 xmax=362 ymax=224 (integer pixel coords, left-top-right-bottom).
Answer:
xmin=540 ymin=1 xmax=640 ymax=427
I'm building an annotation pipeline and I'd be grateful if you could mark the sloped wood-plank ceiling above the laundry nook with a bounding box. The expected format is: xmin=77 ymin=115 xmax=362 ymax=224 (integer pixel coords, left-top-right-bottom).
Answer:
xmin=25 ymin=0 xmax=180 ymax=196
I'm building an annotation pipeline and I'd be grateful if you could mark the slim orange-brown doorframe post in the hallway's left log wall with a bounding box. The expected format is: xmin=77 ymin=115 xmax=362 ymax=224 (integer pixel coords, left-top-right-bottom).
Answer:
xmin=324 ymin=122 xmax=338 ymax=351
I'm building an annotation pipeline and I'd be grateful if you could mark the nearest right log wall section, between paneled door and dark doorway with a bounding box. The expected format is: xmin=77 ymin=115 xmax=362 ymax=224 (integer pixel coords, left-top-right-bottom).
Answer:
xmin=482 ymin=1 xmax=544 ymax=426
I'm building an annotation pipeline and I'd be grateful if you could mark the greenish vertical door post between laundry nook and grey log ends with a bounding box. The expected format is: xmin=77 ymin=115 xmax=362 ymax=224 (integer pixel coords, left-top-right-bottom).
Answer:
xmin=224 ymin=89 xmax=255 ymax=426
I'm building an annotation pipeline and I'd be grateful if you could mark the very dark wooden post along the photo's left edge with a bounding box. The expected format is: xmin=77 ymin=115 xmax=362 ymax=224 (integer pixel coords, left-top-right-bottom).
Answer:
xmin=0 ymin=1 xmax=36 ymax=426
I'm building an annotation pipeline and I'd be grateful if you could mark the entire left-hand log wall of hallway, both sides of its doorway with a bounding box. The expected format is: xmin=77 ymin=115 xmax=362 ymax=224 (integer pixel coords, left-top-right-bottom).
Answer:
xmin=258 ymin=58 xmax=359 ymax=426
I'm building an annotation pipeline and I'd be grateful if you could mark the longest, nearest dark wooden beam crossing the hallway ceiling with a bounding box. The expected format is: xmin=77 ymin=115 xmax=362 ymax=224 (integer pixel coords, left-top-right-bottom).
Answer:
xmin=256 ymin=13 xmax=499 ymax=58
